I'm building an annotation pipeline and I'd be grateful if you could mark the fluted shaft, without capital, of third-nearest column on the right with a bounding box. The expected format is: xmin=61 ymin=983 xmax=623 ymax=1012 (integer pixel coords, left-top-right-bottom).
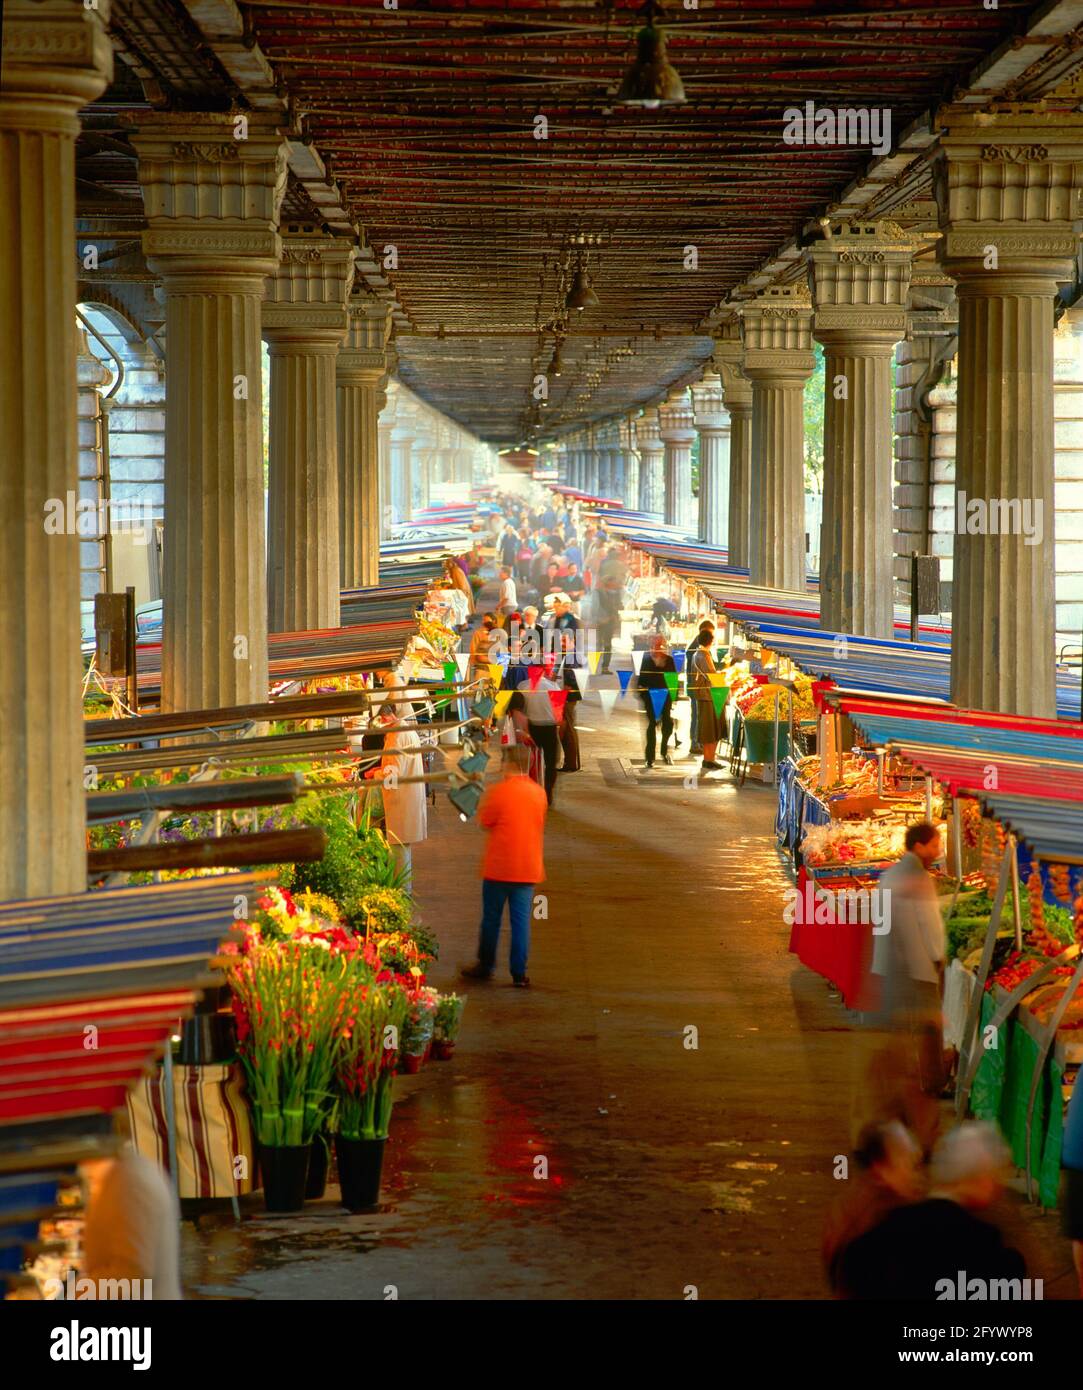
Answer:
xmin=748 ymin=377 xmax=805 ymax=589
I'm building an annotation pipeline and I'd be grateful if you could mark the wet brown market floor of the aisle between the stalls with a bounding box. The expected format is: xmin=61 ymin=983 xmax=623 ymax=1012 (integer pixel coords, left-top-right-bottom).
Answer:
xmin=185 ymin=680 xmax=1073 ymax=1300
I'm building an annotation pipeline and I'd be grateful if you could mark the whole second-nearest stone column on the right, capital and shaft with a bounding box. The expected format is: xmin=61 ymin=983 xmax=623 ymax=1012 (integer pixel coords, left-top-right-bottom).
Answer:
xmin=808 ymin=221 xmax=912 ymax=638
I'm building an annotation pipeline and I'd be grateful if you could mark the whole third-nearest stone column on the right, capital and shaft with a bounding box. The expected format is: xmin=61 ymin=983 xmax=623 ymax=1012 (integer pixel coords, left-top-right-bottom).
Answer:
xmin=741 ymin=285 xmax=813 ymax=591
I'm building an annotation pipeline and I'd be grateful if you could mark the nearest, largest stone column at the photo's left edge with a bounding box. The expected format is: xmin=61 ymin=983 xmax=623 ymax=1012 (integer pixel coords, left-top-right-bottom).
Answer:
xmin=0 ymin=0 xmax=113 ymax=901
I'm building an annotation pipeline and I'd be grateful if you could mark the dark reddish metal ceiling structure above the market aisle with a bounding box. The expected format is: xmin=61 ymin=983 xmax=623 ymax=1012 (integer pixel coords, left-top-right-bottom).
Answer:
xmin=71 ymin=0 xmax=1083 ymax=443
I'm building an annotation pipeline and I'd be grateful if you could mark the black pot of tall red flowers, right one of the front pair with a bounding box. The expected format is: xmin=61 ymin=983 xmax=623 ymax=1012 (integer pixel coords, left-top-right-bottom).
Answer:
xmin=335 ymin=959 xmax=407 ymax=1212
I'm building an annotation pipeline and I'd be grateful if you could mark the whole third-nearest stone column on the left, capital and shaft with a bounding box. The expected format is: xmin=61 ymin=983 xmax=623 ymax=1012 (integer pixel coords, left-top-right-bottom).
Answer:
xmin=263 ymin=235 xmax=356 ymax=632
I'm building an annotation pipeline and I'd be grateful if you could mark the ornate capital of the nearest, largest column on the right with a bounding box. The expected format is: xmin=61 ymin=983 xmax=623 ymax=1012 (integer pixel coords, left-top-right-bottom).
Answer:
xmin=933 ymin=100 xmax=1083 ymax=295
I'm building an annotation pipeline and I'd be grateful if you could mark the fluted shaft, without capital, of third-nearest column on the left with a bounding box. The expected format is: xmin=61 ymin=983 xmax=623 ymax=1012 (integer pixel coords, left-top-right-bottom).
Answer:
xmin=264 ymin=328 xmax=342 ymax=632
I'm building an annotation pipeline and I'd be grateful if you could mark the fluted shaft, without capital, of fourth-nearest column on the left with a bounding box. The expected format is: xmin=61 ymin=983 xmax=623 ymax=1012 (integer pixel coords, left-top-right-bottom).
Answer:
xmin=335 ymin=367 xmax=380 ymax=589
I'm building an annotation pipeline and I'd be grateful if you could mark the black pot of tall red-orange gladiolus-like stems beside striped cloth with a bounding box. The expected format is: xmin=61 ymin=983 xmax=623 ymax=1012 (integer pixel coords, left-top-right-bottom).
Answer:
xmin=229 ymin=937 xmax=349 ymax=1212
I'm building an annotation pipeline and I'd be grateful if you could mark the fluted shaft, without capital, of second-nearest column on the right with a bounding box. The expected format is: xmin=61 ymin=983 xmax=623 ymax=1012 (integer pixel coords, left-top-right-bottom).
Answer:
xmin=817 ymin=341 xmax=895 ymax=638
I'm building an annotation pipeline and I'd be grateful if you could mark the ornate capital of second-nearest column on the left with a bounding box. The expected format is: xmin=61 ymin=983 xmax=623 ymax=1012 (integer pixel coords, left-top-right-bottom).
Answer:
xmin=131 ymin=111 xmax=286 ymax=282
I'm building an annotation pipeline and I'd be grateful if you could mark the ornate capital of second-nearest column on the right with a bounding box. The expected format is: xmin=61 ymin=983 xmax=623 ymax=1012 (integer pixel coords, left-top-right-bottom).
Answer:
xmin=808 ymin=220 xmax=918 ymax=353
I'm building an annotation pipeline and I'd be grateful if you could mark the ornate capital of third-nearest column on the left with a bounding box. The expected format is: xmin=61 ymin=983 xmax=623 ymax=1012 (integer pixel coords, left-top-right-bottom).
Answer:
xmin=263 ymin=234 xmax=357 ymax=348
